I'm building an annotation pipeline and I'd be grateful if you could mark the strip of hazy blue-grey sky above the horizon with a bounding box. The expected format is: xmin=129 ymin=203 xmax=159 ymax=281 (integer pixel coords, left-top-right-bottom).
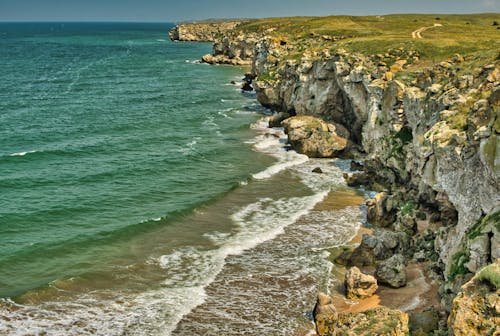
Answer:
xmin=0 ymin=0 xmax=500 ymax=22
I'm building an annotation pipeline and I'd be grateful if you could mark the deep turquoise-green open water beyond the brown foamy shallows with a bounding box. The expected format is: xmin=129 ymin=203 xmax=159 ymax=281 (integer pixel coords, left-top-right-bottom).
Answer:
xmin=0 ymin=24 xmax=272 ymax=296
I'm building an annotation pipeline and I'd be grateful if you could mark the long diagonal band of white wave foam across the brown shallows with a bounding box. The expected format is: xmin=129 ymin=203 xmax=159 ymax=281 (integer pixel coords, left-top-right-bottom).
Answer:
xmin=155 ymin=191 xmax=328 ymax=332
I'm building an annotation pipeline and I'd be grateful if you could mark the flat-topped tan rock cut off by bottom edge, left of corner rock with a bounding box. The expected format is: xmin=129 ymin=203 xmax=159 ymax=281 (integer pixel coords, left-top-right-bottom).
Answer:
xmin=332 ymin=307 xmax=409 ymax=336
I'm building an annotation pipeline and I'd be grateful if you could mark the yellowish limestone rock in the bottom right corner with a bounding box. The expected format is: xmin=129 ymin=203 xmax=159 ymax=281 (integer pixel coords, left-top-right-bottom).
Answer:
xmin=448 ymin=259 xmax=500 ymax=336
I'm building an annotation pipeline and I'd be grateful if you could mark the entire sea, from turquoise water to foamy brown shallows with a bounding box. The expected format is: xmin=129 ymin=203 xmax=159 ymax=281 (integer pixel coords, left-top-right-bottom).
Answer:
xmin=0 ymin=23 xmax=363 ymax=336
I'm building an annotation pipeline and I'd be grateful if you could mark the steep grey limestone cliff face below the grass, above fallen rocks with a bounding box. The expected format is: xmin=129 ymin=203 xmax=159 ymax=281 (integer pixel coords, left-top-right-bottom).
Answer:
xmin=253 ymin=39 xmax=500 ymax=288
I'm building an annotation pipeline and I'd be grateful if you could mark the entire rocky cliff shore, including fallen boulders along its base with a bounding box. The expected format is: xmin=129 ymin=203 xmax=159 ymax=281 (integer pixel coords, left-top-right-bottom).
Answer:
xmin=171 ymin=16 xmax=500 ymax=335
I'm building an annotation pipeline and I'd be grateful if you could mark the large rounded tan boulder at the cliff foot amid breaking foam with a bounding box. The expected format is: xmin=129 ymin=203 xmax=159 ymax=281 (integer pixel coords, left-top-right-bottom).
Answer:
xmin=282 ymin=116 xmax=348 ymax=158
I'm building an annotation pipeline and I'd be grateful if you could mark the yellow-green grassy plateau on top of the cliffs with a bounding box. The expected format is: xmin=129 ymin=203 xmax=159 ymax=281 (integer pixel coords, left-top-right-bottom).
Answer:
xmin=231 ymin=13 xmax=500 ymax=79
